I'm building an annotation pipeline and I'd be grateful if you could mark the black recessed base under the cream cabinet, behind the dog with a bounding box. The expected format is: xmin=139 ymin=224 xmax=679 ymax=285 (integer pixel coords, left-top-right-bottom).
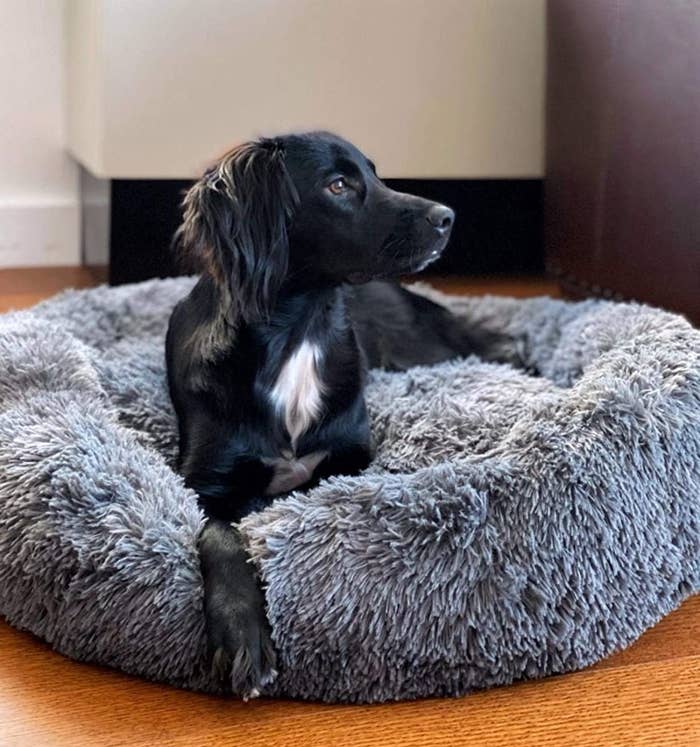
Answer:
xmin=83 ymin=179 xmax=544 ymax=285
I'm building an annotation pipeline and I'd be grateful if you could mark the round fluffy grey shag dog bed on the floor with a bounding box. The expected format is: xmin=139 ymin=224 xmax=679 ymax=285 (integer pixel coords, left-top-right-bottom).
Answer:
xmin=0 ymin=279 xmax=700 ymax=701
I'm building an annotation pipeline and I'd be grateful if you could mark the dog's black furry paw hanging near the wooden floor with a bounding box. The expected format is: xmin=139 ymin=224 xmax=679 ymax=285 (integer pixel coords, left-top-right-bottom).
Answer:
xmin=207 ymin=600 xmax=277 ymax=700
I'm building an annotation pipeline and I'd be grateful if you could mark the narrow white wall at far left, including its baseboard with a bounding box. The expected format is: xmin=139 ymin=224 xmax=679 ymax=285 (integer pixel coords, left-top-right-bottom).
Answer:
xmin=0 ymin=0 xmax=80 ymax=267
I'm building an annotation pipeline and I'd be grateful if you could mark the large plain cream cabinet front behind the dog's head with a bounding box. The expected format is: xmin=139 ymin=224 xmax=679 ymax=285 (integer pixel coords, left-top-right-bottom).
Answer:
xmin=69 ymin=0 xmax=545 ymax=178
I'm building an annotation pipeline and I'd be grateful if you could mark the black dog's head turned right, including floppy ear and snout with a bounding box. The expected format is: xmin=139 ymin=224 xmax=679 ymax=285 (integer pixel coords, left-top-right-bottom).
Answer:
xmin=177 ymin=133 xmax=454 ymax=321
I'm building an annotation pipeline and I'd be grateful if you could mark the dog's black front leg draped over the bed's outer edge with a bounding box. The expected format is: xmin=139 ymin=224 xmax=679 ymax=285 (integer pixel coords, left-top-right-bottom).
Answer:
xmin=199 ymin=518 xmax=275 ymax=700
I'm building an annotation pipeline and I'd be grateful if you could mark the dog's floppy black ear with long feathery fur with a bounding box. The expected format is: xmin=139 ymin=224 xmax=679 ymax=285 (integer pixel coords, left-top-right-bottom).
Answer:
xmin=175 ymin=139 xmax=298 ymax=322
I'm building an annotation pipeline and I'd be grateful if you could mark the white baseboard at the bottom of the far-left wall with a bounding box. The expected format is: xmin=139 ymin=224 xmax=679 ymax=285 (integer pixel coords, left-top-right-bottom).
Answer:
xmin=0 ymin=200 xmax=81 ymax=268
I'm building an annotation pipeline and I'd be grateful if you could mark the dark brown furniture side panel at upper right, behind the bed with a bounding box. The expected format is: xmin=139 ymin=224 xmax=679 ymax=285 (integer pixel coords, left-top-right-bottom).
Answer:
xmin=545 ymin=0 xmax=700 ymax=324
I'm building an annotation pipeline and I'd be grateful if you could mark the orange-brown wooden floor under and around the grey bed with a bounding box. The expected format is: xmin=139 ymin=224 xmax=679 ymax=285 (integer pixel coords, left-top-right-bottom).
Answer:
xmin=0 ymin=269 xmax=700 ymax=747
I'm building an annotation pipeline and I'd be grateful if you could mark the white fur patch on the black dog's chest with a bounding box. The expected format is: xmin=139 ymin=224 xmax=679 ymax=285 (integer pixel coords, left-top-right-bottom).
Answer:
xmin=270 ymin=340 xmax=324 ymax=446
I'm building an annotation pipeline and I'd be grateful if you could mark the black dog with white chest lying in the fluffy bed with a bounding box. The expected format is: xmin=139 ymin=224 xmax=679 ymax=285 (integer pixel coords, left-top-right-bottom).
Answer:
xmin=167 ymin=133 xmax=482 ymax=697
